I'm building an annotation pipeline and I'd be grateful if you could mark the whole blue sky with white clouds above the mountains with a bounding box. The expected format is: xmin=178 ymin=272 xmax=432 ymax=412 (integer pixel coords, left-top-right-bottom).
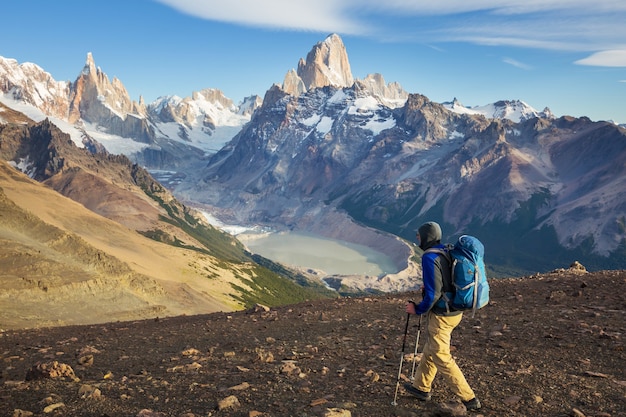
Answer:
xmin=0 ymin=0 xmax=626 ymax=123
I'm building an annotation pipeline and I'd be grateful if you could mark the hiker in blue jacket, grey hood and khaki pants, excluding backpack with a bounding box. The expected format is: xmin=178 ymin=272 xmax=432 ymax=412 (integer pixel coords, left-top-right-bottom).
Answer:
xmin=404 ymin=222 xmax=481 ymax=410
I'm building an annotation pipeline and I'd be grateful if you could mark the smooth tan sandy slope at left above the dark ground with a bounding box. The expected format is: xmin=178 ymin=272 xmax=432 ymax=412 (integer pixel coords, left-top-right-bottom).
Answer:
xmin=0 ymin=161 xmax=256 ymax=329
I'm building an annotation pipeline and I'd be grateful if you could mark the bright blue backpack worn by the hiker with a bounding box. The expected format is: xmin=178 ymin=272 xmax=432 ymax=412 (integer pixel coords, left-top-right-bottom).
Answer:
xmin=427 ymin=235 xmax=489 ymax=317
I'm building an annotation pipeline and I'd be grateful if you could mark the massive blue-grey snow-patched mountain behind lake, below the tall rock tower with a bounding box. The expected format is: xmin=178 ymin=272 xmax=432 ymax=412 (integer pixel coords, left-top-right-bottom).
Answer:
xmin=177 ymin=33 xmax=626 ymax=271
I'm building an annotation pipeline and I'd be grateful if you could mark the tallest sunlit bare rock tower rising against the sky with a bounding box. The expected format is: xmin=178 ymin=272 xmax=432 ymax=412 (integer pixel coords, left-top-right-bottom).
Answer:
xmin=297 ymin=34 xmax=354 ymax=90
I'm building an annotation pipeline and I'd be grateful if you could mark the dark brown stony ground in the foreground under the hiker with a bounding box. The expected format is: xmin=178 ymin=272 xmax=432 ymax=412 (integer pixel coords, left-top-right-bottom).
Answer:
xmin=0 ymin=270 xmax=626 ymax=417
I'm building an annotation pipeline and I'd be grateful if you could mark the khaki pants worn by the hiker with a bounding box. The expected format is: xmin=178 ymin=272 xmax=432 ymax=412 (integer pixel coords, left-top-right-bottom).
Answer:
xmin=413 ymin=312 xmax=475 ymax=401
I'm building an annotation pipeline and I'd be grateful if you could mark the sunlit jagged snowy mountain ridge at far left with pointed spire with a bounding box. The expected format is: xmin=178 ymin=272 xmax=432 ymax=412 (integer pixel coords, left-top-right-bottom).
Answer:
xmin=0 ymin=53 xmax=261 ymax=168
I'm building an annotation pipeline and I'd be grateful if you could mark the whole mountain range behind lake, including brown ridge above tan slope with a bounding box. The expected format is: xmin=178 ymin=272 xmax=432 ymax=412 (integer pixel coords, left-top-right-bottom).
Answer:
xmin=0 ymin=34 xmax=626 ymax=316
